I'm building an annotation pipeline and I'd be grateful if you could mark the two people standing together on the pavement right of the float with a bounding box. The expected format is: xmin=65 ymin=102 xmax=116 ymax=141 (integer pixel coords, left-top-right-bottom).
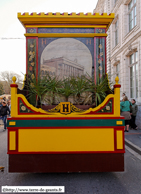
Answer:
xmin=120 ymin=93 xmax=138 ymax=132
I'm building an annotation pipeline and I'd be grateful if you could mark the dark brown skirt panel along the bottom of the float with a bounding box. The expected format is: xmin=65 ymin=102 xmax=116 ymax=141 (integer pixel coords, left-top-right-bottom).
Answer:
xmin=9 ymin=153 xmax=124 ymax=173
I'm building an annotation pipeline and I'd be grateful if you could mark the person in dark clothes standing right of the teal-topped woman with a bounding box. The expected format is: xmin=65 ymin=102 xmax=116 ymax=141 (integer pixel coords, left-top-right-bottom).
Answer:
xmin=130 ymin=99 xmax=138 ymax=130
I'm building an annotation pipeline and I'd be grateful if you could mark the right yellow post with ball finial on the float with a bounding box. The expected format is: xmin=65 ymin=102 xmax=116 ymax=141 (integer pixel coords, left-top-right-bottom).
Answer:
xmin=114 ymin=76 xmax=121 ymax=117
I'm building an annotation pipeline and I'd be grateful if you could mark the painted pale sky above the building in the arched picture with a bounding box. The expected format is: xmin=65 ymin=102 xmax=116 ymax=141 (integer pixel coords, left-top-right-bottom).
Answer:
xmin=41 ymin=38 xmax=92 ymax=75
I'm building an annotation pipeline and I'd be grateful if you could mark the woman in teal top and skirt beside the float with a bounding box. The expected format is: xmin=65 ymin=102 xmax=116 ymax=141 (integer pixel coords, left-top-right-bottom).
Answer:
xmin=120 ymin=96 xmax=132 ymax=132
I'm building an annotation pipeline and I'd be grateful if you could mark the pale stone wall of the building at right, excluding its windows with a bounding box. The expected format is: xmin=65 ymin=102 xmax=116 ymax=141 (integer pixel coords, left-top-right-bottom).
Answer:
xmin=94 ymin=0 xmax=141 ymax=128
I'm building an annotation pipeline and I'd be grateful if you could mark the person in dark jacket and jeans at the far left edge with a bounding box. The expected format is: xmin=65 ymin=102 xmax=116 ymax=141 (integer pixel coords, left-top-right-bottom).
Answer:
xmin=0 ymin=100 xmax=10 ymax=131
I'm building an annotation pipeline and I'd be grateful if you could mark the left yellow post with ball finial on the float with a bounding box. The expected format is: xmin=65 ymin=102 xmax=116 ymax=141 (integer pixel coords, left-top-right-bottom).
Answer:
xmin=10 ymin=76 xmax=18 ymax=117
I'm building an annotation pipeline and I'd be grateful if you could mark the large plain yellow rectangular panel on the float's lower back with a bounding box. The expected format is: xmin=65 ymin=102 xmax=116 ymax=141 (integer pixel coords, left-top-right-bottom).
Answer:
xmin=18 ymin=128 xmax=114 ymax=152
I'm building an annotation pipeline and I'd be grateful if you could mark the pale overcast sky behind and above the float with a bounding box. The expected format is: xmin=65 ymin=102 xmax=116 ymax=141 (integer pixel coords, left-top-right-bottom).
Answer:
xmin=0 ymin=0 xmax=97 ymax=79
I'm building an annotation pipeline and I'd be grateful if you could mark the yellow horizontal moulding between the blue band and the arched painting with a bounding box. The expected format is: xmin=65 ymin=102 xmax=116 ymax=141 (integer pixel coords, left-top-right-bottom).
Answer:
xmin=24 ymin=33 xmax=107 ymax=38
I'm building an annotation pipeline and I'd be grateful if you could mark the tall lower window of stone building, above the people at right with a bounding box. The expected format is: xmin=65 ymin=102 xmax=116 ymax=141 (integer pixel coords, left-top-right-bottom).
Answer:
xmin=130 ymin=52 xmax=138 ymax=98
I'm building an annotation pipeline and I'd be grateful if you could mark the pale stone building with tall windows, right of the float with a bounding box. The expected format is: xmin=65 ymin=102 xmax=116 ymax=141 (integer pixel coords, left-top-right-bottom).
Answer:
xmin=94 ymin=0 xmax=141 ymax=127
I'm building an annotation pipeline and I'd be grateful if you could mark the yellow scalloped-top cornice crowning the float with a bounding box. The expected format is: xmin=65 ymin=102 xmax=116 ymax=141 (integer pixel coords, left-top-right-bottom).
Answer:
xmin=18 ymin=12 xmax=114 ymax=28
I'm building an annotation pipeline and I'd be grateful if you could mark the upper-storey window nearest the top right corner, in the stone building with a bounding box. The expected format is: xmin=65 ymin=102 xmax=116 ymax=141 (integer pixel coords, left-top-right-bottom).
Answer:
xmin=128 ymin=0 xmax=137 ymax=31
